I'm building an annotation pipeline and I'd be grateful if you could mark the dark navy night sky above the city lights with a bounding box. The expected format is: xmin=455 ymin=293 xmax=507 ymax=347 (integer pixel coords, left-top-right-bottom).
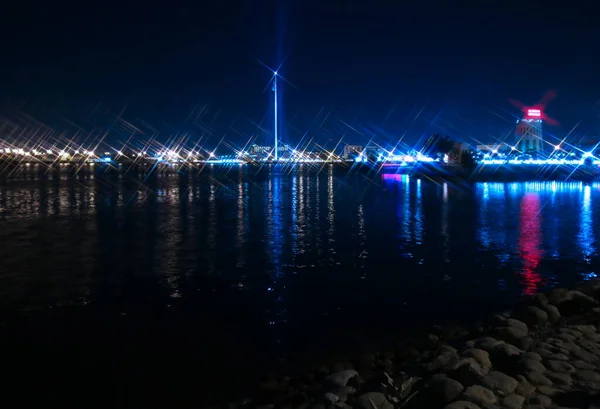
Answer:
xmin=0 ymin=0 xmax=600 ymax=147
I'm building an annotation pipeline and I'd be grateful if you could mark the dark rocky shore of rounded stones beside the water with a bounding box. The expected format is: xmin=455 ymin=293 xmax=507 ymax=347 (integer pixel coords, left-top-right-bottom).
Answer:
xmin=221 ymin=281 xmax=600 ymax=409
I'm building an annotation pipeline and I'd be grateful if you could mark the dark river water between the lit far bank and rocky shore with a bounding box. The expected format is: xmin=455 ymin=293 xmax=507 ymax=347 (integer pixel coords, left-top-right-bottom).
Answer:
xmin=0 ymin=166 xmax=600 ymax=407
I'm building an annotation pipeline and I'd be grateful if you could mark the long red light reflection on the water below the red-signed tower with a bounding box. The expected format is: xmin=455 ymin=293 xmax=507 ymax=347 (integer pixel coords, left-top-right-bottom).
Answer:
xmin=519 ymin=193 xmax=543 ymax=295
